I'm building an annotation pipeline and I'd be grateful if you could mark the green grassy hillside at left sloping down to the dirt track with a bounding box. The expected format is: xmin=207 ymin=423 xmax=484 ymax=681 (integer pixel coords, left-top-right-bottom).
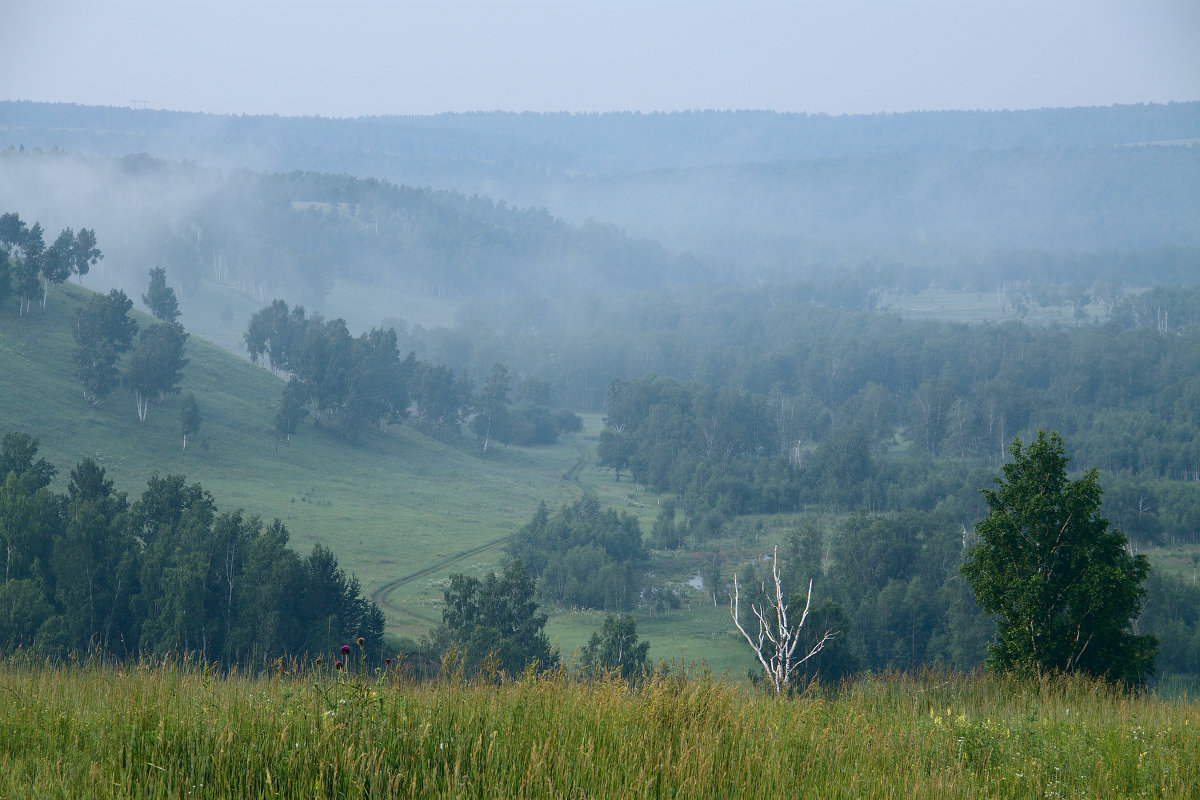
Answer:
xmin=0 ymin=284 xmax=581 ymax=636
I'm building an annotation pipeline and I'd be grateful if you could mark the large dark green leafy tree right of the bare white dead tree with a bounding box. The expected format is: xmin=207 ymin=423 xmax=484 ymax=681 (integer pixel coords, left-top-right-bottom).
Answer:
xmin=962 ymin=431 xmax=1157 ymax=686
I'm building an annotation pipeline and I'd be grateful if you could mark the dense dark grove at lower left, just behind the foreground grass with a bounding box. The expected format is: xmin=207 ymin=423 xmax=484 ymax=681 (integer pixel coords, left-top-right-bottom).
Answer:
xmin=0 ymin=433 xmax=384 ymax=668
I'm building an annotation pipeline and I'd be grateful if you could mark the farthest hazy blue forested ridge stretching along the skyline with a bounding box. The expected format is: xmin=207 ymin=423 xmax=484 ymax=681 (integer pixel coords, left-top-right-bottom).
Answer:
xmin=0 ymin=102 xmax=1200 ymax=287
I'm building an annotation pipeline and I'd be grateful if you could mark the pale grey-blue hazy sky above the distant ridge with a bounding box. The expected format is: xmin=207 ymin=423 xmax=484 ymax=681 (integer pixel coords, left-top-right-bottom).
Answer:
xmin=0 ymin=0 xmax=1200 ymax=116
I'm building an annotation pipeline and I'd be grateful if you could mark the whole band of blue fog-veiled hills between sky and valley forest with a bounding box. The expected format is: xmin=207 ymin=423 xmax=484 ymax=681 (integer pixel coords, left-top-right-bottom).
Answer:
xmin=0 ymin=102 xmax=1200 ymax=340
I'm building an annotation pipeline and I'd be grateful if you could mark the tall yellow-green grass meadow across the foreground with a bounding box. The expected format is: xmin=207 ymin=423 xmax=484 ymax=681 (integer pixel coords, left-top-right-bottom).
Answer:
xmin=0 ymin=661 xmax=1200 ymax=798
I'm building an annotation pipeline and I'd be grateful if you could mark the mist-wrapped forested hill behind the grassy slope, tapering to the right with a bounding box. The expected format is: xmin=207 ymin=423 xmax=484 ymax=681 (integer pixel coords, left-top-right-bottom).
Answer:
xmin=0 ymin=150 xmax=706 ymax=307
